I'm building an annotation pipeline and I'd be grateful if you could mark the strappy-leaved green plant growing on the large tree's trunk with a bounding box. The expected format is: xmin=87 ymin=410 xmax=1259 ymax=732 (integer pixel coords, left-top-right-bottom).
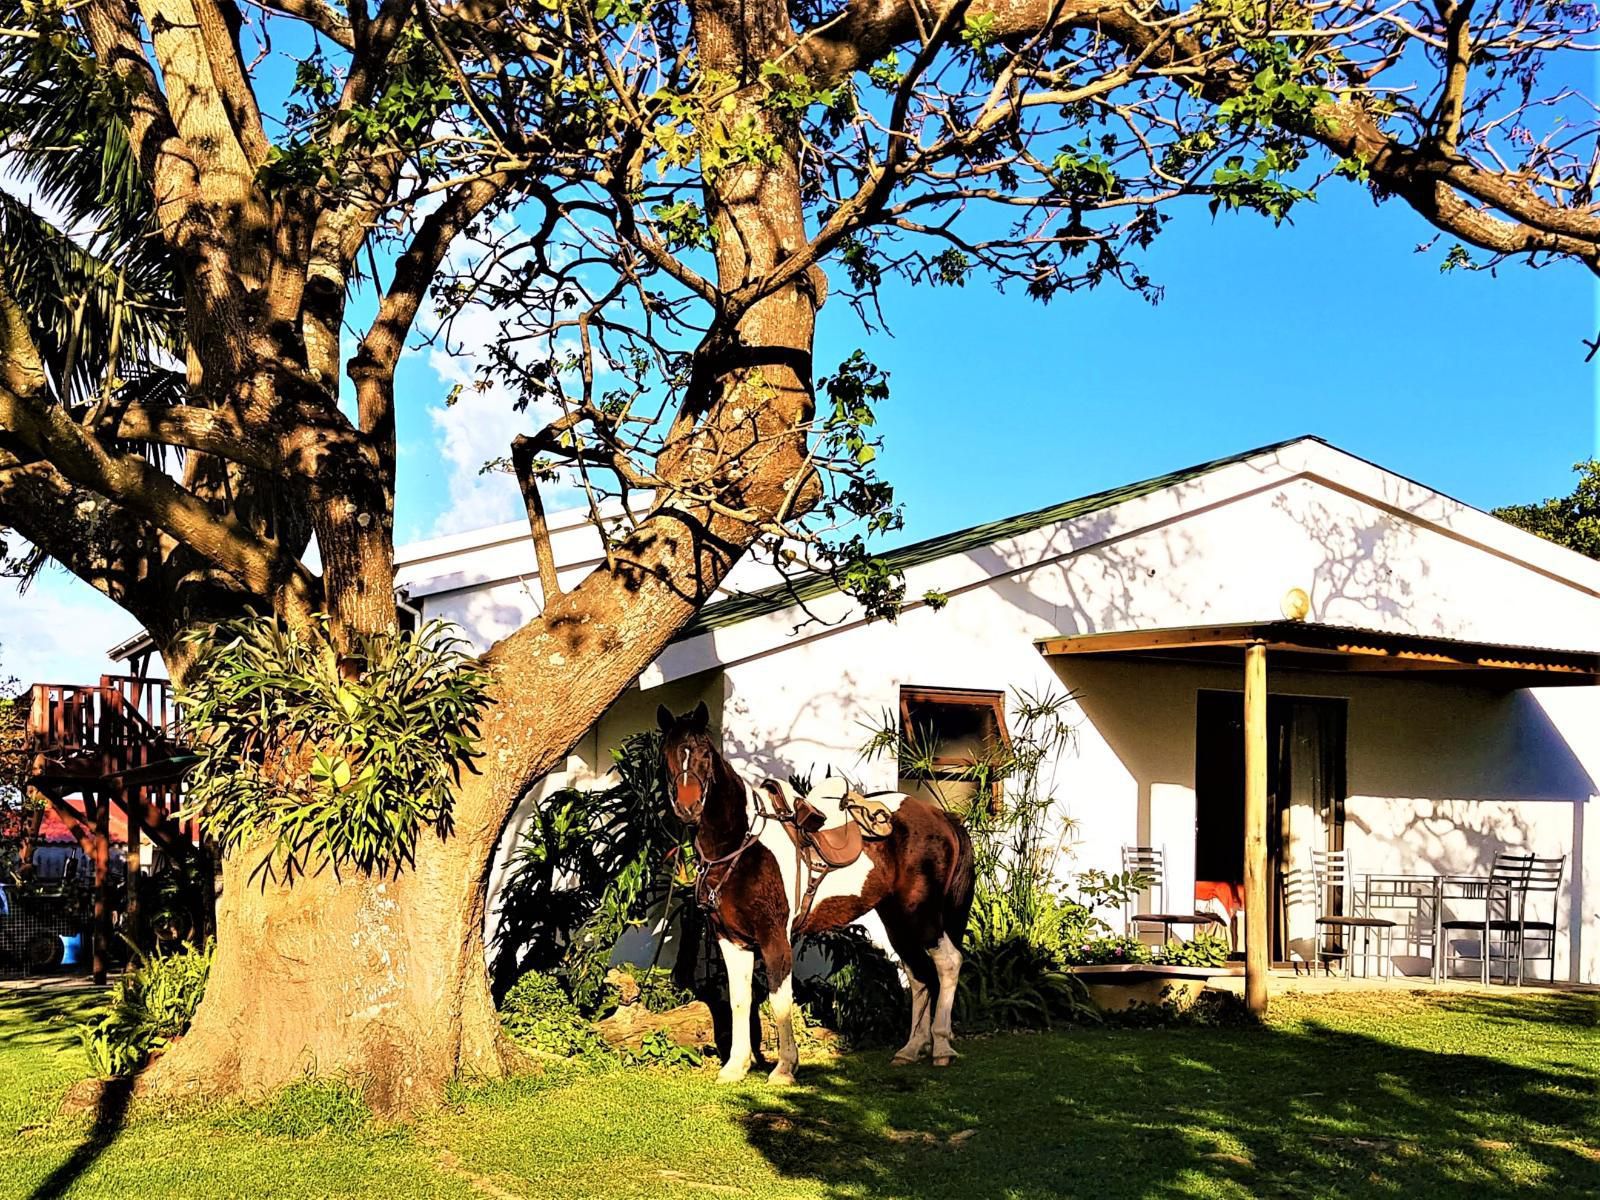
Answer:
xmin=179 ymin=618 xmax=488 ymax=874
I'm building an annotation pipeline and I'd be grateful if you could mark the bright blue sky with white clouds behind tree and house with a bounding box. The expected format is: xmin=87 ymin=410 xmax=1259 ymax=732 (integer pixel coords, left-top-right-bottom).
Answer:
xmin=0 ymin=40 xmax=1600 ymax=680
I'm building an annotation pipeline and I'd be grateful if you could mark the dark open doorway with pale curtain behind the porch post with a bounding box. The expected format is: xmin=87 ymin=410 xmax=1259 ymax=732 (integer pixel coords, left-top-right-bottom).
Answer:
xmin=1195 ymin=691 xmax=1347 ymax=963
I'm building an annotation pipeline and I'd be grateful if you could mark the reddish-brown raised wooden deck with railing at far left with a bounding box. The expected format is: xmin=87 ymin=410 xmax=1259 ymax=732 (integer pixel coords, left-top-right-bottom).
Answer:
xmin=24 ymin=675 xmax=208 ymax=982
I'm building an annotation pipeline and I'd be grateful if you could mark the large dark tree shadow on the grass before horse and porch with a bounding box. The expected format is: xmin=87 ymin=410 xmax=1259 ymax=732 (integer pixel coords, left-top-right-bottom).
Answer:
xmin=739 ymin=1022 xmax=1600 ymax=1198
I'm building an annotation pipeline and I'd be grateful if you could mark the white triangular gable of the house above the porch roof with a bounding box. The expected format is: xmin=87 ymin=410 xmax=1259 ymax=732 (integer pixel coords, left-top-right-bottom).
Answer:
xmin=642 ymin=437 xmax=1600 ymax=686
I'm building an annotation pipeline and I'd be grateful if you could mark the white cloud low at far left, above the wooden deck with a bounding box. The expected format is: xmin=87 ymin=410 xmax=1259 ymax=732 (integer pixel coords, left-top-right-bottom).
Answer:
xmin=0 ymin=566 xmax=139 ymax=685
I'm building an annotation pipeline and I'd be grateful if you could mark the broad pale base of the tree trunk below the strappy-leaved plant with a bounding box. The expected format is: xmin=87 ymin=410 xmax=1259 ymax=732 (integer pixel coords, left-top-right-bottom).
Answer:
xmin=139 ymin=835 xmax=509 ymax=1117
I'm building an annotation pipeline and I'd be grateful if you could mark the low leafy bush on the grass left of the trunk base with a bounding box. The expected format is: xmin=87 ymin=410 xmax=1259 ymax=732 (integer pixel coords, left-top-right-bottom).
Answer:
xmin=78 ymin=942 xmax=213 ymax=1078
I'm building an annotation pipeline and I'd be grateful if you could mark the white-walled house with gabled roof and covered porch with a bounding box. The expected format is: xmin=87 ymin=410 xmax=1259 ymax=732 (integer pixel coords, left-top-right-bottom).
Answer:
xmin=137 ymin=437 xmax=1600 ymax=982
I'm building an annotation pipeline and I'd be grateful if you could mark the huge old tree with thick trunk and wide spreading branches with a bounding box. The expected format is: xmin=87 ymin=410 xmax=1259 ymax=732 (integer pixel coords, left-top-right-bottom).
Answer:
xmin=0 ymin=0 xmax=1600 ymax=1109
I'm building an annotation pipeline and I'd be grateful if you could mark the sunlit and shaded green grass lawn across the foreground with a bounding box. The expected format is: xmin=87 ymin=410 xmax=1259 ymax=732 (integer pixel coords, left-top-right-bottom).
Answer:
xmin=0 ymin=992 xmax=1600 ymax=1200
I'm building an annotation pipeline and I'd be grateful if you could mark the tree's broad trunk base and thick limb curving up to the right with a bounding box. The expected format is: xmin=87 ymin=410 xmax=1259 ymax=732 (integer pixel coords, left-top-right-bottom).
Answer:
xmin=132 ymin=2 xmax=826 ymax=1114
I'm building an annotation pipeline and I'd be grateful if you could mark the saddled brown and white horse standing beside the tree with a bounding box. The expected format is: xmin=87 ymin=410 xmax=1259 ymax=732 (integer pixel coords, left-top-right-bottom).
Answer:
xmin=658 ymin=704 xmax=973 ymax=1083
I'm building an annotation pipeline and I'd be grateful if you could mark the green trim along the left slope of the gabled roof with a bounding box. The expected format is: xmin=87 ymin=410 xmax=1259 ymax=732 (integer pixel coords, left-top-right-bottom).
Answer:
xmin=675 ymin=435 xmax=1328 ymax=642
